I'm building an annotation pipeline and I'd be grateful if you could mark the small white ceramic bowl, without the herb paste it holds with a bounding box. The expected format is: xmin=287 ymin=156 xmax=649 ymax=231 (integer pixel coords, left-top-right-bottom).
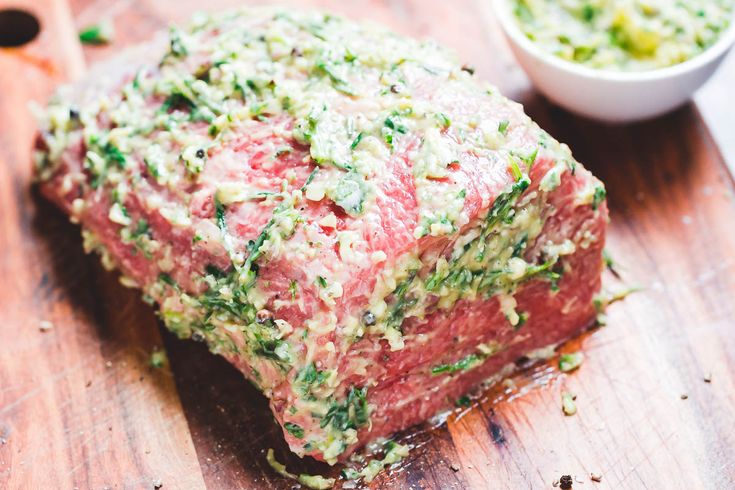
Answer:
xmin=494 ymin=0 xmax=735 ymax=122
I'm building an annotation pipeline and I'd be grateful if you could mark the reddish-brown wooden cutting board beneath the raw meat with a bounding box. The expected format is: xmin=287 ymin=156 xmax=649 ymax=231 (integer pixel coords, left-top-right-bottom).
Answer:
xmin=0 ymin=0 xmax=735 ymax=490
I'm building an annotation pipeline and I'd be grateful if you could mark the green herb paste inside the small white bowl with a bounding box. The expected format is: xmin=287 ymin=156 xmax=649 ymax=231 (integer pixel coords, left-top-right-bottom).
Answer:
xmin=513 ymin=0 xmax=733 ymax=71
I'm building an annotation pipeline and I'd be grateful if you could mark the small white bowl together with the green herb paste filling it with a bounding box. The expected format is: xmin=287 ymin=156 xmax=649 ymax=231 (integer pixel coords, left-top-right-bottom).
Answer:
xmin=493 ymin=0 xmax=735 ymax=122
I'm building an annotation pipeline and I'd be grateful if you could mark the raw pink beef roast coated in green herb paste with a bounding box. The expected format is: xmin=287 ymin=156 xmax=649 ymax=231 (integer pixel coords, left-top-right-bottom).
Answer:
xmin=35 ymin=9 xmax=607 ymax=463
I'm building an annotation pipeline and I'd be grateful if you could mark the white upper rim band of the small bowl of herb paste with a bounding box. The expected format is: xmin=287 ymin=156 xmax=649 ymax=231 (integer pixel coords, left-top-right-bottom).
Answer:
xmin=493 ymin=0 xmax=735 ymax=83
